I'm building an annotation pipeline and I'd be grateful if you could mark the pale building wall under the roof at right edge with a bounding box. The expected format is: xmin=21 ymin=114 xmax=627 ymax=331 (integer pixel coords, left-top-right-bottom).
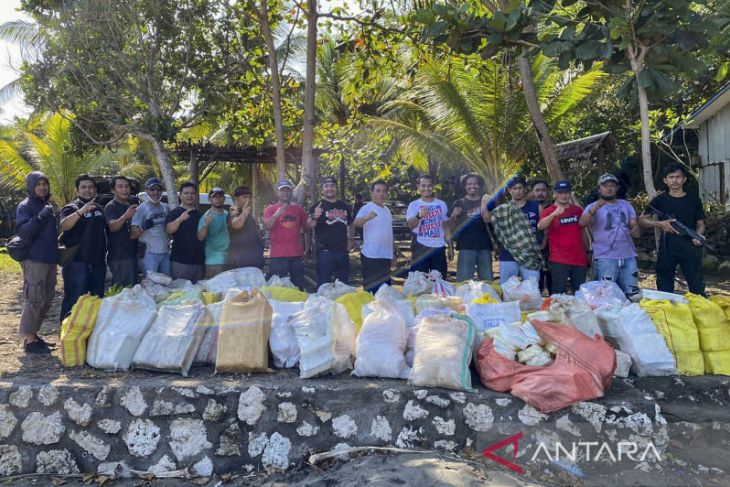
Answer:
xmin=699 ymin=104 xmax=730 ymax=210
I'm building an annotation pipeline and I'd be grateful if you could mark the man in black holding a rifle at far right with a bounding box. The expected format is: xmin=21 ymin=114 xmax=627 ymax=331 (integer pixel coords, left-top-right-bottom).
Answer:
xmin=639 ymin=163 xmax=705 ymax=296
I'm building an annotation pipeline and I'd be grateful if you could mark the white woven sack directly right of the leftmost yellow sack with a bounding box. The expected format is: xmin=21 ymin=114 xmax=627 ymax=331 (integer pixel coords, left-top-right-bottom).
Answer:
xmin=86 ymin=285 xmax=157 ymax=370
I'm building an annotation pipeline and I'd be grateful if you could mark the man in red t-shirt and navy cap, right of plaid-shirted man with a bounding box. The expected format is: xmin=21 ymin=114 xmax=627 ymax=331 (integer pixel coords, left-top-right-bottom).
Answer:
xmin=537 ymin=180 xmax=588 ymax=294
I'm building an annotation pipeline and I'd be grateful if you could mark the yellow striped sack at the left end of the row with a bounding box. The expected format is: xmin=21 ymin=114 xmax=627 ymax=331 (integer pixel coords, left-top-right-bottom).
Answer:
xmin=61 ymin=294 xmax=101 ymax=367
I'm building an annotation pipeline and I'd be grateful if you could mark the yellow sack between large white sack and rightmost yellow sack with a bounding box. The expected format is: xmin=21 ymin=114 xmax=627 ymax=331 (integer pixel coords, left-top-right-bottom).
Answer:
xmin=639 ymin=299 xmax=705 ymax=375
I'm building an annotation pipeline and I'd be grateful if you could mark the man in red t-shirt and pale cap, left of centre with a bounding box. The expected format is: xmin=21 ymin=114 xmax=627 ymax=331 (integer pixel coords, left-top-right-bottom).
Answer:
xmin=264 ymin=179 xmax=307 ymax=290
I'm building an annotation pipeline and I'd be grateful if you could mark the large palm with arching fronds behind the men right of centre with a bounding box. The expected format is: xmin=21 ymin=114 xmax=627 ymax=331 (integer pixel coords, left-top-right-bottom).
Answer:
xmin=367 ymin=55 xmax=605 ymax=188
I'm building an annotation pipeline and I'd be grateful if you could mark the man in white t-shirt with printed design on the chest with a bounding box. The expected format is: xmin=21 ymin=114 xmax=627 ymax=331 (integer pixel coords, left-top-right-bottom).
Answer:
xmin=406 ymin=175 xmax=450 ymax=279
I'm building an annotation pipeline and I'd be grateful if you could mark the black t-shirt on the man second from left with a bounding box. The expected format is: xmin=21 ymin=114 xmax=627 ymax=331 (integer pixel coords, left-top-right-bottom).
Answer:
xmin=61 ymin=198 xmax=106 ymax=265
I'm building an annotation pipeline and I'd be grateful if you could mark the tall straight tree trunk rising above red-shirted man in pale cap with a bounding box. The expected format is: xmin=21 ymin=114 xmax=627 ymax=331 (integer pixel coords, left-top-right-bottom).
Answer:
xmin=295 ymin=0 xmax=317 ymax=206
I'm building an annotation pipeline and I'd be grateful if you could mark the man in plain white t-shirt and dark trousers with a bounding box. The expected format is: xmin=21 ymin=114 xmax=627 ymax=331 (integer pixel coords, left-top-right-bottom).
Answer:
xmin=355 ymin=180 xmax=395 ymax=293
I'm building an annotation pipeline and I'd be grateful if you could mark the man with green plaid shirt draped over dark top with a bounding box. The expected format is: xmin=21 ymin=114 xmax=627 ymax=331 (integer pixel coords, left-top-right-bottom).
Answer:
xmin=485 ymin=176 xmax=543 ymax=283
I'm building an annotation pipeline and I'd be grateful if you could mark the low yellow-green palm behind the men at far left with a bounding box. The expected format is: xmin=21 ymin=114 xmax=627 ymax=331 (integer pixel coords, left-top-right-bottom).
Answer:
xmin=0 ymin=113 xmax=152 ymax=206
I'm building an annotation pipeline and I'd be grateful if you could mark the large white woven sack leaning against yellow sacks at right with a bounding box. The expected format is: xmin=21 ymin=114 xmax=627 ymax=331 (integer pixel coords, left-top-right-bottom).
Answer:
xmin=596 ymin=303 xmax=677 ymax=377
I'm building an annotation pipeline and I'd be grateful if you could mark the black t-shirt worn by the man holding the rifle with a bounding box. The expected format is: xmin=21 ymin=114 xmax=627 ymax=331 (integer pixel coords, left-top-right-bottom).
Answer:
xmin=646 ymin=193 xmax=705 ymax=256
